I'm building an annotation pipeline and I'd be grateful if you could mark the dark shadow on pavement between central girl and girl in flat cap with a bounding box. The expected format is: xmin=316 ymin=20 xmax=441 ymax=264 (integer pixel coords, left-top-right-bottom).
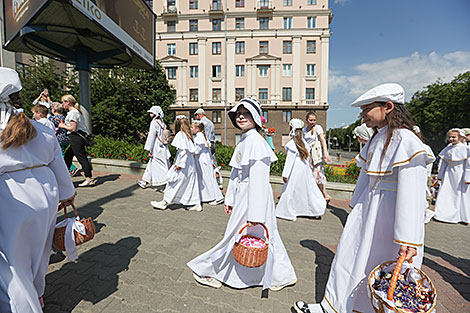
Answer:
xmin=299 ymin=239 xmax=335 ymax=303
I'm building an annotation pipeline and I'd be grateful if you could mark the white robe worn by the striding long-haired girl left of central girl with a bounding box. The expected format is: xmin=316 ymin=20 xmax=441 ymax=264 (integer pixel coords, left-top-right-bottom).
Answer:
xmin=163 ymin=131 xmax=201 ymax=206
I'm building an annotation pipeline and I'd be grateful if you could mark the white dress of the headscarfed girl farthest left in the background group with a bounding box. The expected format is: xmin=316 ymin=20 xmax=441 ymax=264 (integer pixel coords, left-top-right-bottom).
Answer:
xmin=142 ymin=117 xmax=170 ymax=186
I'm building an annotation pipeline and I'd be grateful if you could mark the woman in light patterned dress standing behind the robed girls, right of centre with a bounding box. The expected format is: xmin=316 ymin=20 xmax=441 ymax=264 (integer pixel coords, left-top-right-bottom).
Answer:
xmin=303 ymin=111 xmax=331 ymax=201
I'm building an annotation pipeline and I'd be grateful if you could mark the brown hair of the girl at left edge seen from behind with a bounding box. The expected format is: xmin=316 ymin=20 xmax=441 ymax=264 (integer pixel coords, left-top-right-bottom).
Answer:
xmin=0 ymin=92 xmax=37 ymax=150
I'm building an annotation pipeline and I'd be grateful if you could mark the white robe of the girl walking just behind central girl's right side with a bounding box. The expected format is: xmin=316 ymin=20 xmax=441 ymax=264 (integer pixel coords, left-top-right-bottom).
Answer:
xmin=276 ymin=139 xmax=326 ymax=221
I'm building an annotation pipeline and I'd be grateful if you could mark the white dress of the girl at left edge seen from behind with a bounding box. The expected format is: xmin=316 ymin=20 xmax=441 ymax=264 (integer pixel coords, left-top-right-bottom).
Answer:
xmin=0 ymin=121 xmax=75 ymax=313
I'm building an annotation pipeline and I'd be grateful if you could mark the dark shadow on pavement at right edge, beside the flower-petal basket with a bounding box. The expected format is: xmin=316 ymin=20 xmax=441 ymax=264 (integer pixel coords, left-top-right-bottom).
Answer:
xmin=423 ymin=247 xmax=470 ymax=301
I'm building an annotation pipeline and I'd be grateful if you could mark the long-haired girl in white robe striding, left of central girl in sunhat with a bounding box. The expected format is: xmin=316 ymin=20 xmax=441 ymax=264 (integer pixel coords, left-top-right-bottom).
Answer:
xmin=151 ymin=115 xmax=202 ymax=211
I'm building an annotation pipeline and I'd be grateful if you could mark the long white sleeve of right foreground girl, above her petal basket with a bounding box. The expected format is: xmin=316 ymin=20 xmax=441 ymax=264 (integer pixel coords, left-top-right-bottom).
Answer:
xmin=394 ymin=155 xmax=427 ymax=247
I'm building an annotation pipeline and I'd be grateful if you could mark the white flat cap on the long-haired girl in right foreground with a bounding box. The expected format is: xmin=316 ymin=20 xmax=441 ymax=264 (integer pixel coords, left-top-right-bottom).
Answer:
xmin=352 ymin=83 xmax=405 ymax=107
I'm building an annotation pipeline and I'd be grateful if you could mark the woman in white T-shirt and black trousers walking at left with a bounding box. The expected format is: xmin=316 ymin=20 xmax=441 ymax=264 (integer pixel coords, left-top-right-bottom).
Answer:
xmin=59 ymin=95 xmax=96 ymax=187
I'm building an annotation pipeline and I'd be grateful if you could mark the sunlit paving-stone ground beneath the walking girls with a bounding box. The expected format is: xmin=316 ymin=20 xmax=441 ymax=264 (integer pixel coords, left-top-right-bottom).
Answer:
xmin=44 ymin=172 xmax=470 ymax=313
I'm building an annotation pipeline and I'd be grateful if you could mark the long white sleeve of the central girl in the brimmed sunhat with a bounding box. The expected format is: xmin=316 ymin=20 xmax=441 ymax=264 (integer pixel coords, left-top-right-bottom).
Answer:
xmin=247 ymin=159 xmax=273 ymax=224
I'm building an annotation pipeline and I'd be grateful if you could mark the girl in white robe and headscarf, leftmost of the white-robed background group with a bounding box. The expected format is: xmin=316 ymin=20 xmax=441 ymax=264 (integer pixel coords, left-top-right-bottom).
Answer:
xmin=137 ymin=105 xmax=170 ymax=188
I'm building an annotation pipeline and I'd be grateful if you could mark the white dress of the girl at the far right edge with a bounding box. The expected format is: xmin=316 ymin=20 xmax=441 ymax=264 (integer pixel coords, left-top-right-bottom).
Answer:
xmin=434 ymin=143 xmax=470 ymax=223
